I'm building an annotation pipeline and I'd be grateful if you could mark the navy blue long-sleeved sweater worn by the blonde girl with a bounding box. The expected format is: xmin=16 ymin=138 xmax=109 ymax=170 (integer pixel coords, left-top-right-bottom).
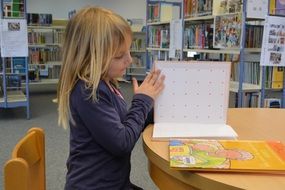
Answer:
xmin=65 ymin=81 xmax=153 ymax=190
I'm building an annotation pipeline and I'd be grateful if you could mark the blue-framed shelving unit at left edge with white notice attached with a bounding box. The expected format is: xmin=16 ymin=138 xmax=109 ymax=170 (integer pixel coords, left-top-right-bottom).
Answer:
xmin=0 ymin=0 xmax=30 ymax=119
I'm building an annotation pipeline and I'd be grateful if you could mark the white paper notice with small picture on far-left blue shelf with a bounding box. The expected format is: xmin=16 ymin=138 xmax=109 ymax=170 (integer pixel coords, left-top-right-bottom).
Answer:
xmin=1 ymin=19 xmax=28 ymax=57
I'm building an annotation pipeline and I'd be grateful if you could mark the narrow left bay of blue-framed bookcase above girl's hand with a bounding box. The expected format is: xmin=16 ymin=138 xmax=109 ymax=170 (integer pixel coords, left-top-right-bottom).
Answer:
xmin=146 ymin=0 xmax=182 ymax=71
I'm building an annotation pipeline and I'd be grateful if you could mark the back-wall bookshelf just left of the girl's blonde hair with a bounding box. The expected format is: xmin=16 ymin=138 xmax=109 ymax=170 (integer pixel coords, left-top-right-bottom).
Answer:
xmin=28 ymin=16 xmax=65 ymax=85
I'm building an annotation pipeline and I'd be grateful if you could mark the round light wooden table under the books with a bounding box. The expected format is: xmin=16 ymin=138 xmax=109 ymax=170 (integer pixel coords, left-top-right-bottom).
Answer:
xmin=143 ymin=108 xmax=285 ymax=190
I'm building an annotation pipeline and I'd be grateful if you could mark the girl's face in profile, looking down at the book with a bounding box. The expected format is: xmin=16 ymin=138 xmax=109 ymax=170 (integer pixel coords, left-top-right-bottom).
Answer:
xmin=108 ymin=37 xmax=132 ymax=80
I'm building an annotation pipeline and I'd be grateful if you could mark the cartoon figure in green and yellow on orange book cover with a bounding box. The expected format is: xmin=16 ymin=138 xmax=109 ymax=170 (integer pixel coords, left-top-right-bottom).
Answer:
xmin=170 ymin=140 xmax=253 ymax=169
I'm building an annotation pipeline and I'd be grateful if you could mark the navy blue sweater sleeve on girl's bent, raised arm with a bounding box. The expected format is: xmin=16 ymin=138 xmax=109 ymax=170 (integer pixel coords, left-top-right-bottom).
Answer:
xmin=73 ymin=86 xmax=153 ymax=157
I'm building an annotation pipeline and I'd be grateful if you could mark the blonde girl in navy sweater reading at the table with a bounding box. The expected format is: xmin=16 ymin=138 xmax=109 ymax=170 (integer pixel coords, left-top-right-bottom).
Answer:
xmin=58 ymin=7 xmax=165 ymax=190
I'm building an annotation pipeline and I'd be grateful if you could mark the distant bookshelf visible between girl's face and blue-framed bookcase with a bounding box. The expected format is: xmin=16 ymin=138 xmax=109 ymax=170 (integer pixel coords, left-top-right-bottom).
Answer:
xmin=125 ymin=31 xmax=146 ymax=80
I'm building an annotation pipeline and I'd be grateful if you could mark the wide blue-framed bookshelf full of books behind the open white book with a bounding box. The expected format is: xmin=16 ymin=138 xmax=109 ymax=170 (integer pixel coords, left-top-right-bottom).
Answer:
xmin=146 ymin=0 xmax=285 ymax=107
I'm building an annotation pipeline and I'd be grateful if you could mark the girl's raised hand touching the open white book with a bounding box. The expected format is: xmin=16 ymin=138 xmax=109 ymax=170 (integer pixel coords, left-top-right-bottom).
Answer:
xmin=133 ymin=70 xmax=165 ymax=100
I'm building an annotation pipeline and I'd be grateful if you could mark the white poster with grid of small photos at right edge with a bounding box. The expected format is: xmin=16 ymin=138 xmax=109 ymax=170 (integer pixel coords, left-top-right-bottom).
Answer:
xmin=260 ymin=16 xmax=285 ymax=66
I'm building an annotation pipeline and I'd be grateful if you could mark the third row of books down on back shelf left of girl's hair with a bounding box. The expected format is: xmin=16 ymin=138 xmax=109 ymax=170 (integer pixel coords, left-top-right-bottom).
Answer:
xmin=29 ymin=47 xmax=62 ymax=64
